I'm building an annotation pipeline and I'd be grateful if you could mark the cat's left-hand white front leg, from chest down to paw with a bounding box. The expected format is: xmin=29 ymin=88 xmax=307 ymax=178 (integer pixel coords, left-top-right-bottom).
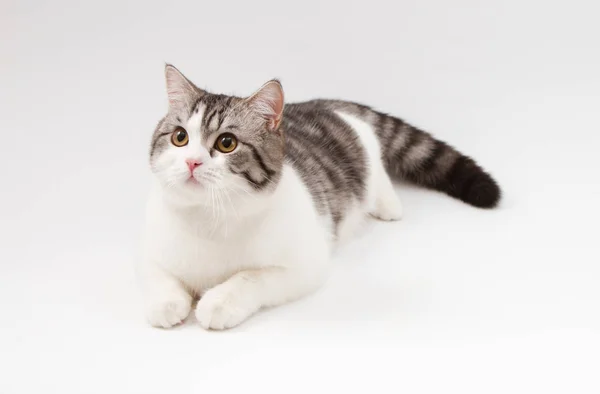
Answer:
xmin=137 ymin=262 xmax=192 ymax=328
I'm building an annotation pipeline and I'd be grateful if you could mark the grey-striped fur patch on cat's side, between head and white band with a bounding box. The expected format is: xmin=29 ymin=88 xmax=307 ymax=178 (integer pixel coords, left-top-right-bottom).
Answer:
xmin=282 ymin=100 xmax=376 ymax=224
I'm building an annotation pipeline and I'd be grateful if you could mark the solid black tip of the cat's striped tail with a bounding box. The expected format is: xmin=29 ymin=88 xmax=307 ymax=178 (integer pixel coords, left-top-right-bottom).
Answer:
xmin=446 ymin=156 xmax=502 ymax=208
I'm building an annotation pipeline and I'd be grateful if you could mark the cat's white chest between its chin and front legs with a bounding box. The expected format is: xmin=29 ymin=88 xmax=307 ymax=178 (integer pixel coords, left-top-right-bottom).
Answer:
xmin=139 ymin=167 xmax=332 ymax=295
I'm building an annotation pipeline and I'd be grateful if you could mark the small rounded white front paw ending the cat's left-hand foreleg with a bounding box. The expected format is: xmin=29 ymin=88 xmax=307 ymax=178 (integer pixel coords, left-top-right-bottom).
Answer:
xmin=146 ymin=292 xmax=192 ymax=328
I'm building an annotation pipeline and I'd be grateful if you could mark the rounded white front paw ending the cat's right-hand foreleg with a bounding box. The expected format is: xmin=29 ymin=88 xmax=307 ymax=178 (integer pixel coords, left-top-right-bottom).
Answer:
xmin=196 ymin=284 xmax=258 ymax=330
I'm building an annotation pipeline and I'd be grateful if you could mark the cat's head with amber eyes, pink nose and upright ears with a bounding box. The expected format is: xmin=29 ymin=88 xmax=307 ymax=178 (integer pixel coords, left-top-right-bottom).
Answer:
xmin=150 ymin=65 xmax=284 ymax=209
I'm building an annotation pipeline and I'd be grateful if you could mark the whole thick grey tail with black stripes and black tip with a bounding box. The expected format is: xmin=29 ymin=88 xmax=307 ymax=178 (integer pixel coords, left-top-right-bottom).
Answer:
xmin=375 ymin=113 xmax=501 ymax=208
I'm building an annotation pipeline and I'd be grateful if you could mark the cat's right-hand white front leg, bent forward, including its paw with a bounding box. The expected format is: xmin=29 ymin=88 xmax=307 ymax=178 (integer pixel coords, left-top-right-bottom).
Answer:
xmin=196 ymin=267 xmax=326 ymax=330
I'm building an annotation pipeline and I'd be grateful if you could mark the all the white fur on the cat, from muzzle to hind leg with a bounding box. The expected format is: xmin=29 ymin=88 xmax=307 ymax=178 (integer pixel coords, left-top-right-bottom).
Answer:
xmin=138 ymin=110 xmax=401 ymax=329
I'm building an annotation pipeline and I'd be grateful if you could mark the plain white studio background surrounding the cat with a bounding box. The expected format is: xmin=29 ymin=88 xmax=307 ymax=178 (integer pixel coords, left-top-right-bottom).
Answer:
xmin=0 ymin=0 xmax=600 ymax=394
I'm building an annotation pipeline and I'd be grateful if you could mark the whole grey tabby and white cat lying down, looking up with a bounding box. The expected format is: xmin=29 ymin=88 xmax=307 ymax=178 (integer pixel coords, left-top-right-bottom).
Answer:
xmin=137 ymin=64 xmax=501 ymax=330
